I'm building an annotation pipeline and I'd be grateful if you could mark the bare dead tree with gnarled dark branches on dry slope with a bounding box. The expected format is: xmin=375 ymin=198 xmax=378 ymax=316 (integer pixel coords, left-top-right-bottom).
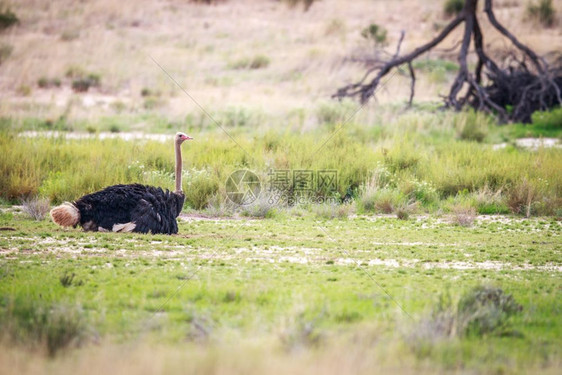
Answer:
xmin=334 ymin=0 xmax=562 ymax=122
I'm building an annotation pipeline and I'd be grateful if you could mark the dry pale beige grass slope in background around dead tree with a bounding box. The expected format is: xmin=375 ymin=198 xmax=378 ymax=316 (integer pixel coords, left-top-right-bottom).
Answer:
xmin=0 ymin=0 xmax=562 ymax=125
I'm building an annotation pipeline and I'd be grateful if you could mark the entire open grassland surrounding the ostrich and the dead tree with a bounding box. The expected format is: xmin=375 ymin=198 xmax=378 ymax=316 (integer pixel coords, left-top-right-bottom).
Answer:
xmin=0 ymin=0 xmax=562 ymax=374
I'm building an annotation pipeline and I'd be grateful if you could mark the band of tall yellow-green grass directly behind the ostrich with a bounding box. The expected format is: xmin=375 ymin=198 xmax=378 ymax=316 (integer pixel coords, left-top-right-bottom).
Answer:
xmin=0 ymin=107 xmax=562 ymax=215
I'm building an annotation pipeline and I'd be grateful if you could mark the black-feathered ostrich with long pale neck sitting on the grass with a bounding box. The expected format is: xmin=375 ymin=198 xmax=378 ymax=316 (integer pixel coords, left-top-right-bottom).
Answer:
xmin=51 ymin=133 xmax=193 ymax=234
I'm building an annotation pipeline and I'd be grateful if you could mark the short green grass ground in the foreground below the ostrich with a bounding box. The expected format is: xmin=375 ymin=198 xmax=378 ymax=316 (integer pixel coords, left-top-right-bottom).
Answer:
xmin=0 ymin=209 xmax=562 ymax=373
